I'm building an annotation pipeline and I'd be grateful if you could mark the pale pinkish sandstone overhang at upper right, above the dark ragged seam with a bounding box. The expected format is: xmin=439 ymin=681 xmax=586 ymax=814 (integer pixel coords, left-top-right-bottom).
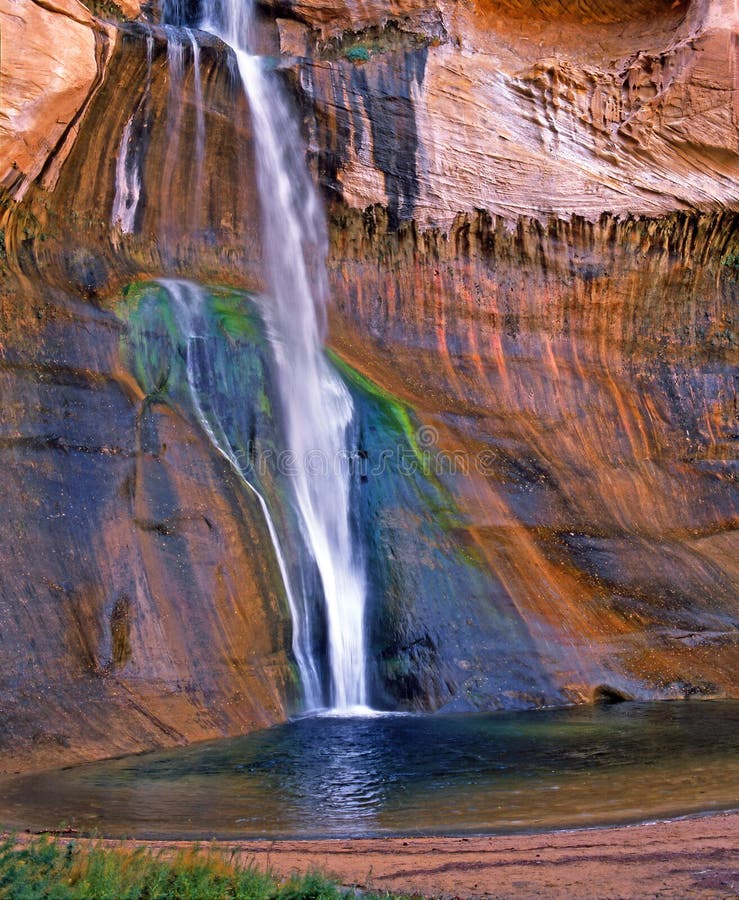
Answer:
xmin=296 ymin=0 xmax=739 ymax=231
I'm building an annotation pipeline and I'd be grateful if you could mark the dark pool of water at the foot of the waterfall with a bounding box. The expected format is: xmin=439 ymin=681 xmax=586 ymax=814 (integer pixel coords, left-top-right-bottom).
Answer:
xmin=0 ymin=701 xmax=739 ymax=838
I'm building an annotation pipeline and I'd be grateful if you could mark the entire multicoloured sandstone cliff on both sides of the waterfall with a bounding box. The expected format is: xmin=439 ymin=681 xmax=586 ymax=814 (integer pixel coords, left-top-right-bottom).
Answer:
xmin=0 ymin=0 xmax=739 ymax=770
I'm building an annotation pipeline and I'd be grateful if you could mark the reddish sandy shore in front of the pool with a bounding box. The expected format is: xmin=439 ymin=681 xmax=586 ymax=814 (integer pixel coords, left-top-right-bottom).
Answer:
xmin=15 ymin=813 xmax=739 ymax=900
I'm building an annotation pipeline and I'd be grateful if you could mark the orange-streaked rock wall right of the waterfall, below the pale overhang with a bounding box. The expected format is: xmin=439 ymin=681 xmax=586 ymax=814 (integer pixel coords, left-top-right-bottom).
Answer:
xmin=332 ymin=213 xmax=739 ymax=705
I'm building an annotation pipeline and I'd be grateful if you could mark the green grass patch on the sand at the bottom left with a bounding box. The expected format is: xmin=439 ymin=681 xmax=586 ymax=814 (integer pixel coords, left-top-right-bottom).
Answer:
xmin=0 ymin=837 xmax=410 ymax=900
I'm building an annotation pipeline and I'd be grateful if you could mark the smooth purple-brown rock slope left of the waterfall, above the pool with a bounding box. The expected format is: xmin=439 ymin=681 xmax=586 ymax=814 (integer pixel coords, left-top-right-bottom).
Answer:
xmin=0 ymin=291 xmax=295 ymax=771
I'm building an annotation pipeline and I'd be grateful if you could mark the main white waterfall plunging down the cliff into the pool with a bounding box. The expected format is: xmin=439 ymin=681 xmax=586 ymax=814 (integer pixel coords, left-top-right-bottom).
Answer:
xmin=165 ymin=0 xmax=367 ymax=710
